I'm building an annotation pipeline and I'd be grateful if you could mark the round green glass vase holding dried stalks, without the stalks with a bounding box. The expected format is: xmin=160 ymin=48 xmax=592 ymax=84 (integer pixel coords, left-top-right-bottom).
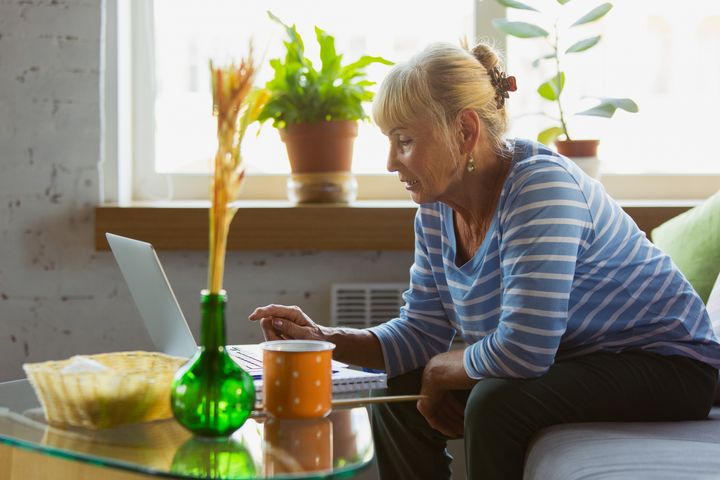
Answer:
xmin=170 ymin=290 xmax=255 ymax=437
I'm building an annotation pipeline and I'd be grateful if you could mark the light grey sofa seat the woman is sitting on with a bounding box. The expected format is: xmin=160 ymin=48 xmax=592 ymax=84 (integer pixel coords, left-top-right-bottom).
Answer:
xmin=523 ymin=407 xmax=720 ymax=480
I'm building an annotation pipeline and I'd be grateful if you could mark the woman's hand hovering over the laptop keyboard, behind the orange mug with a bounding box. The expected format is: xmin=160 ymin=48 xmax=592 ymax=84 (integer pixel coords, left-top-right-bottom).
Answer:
xmin=248 ymin=305 xmax=328 ymax=340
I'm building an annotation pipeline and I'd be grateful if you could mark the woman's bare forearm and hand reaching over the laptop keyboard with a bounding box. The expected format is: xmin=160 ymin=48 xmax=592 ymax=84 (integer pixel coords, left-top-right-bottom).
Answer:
xmin=248 ymin=305 xmax=385 ymax=370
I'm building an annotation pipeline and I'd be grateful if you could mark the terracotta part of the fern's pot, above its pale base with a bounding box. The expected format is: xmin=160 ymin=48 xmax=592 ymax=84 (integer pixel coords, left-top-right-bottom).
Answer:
xmin=280 ymin=120 xmax=358 ymax=173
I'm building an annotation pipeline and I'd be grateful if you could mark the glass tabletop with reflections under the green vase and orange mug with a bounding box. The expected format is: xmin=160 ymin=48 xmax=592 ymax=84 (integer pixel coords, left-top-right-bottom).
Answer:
xmin=0 ymin=380 xmax=374 ymax=480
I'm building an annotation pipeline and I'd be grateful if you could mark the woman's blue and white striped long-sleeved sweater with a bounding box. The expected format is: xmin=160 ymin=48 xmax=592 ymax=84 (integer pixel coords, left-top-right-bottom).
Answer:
xmin=371 ymin=140 xmax=720 ymax=379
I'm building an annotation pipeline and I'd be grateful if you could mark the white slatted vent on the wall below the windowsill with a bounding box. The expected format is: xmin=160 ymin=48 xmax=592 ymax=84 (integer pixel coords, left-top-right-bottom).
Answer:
xmin=330 ymin=283 xmax=408 ymax=328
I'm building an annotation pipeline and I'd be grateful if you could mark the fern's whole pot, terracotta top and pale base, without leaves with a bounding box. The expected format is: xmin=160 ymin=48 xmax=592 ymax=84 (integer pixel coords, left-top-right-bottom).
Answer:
xmin=280 ymin=120 xmax=358 ymax=203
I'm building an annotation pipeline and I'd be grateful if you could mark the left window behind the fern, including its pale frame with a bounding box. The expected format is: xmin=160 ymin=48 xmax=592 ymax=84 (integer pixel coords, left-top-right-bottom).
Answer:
xmin=107 ymin=0 xmax=474 ymax=199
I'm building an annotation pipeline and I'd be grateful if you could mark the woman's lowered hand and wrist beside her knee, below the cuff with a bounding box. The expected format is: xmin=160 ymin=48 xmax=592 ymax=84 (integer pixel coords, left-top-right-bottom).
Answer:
xmin=417 ymin=350 xmax=476 ymax=438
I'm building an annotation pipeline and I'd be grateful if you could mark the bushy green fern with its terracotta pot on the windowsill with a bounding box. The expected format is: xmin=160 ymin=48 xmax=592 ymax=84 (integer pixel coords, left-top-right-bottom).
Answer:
xmin=258 ymin=12 xmax=392 ymax=202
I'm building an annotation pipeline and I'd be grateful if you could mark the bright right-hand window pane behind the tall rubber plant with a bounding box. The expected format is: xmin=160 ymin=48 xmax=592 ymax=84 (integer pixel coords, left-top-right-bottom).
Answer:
xmin=508 ymin=0 xmax=720 ymax=175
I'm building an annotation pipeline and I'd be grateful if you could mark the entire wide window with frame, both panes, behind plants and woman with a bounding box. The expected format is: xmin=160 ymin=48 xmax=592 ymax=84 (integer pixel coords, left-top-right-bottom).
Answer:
xmin=105 ymin=0 xmax=720 ymax=200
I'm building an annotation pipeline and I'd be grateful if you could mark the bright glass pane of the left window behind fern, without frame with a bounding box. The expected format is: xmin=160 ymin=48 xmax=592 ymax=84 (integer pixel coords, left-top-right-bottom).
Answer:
xmin=153 ymin=0 xmax=472 ymax=174
